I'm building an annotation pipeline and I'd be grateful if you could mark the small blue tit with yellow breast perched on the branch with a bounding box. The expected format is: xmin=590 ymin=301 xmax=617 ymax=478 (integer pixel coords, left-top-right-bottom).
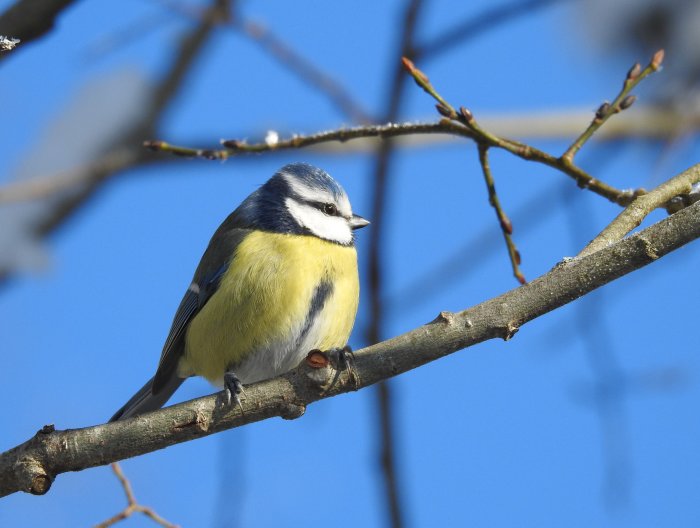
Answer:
xmin=110 ymin=163 xmax=369 ymax=421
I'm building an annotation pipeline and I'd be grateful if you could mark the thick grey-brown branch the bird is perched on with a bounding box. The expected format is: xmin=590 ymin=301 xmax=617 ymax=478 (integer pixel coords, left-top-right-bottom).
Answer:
xmin=0 ymin=198 xmax=700 ymax=496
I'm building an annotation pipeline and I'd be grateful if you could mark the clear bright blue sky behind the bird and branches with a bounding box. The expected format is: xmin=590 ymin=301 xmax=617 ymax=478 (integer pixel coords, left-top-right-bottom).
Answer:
xmin=0 ymin=0 xmax=700 ymax=528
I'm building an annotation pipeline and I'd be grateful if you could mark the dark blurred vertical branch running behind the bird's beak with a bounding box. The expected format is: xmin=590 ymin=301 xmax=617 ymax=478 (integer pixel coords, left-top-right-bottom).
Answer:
xmin=365 ymin=0 xmax=422 ymax=528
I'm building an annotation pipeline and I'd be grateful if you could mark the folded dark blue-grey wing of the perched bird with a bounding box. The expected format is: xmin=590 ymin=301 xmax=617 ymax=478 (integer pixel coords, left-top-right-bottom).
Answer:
xmin=152 ymin=217 xmax=250 ymax=394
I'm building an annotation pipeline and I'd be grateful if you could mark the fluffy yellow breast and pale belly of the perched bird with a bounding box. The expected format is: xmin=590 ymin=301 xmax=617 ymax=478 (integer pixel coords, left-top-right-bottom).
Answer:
xmin=179 ymin=231 xmax=359 ymax=384
